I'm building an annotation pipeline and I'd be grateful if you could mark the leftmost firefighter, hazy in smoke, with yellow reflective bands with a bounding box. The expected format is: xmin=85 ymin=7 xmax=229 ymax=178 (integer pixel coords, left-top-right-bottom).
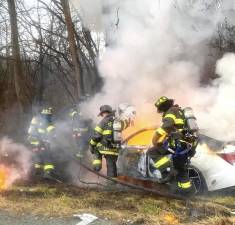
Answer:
xmin=28 ymin=107 xmax=55 ymax=178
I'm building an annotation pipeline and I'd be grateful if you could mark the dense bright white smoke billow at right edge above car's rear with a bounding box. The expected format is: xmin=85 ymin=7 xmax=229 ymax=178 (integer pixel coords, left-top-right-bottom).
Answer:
xmin=199 ymin=53 xmax=235 ymax=140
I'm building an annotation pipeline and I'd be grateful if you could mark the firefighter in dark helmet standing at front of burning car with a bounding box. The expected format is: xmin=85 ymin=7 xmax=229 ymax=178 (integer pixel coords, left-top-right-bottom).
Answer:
xmin=90 ymin=105 xmax=129 ymax=178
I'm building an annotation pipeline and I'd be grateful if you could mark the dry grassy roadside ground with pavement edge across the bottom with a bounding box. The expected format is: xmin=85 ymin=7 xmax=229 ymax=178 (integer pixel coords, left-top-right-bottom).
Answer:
xmin=0 ymin=183 xmax=235 ymax=225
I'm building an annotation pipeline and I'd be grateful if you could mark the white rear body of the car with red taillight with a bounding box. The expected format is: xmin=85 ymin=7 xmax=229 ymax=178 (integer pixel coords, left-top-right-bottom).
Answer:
xmin=190 ymin=135 xmax=235 ymax=191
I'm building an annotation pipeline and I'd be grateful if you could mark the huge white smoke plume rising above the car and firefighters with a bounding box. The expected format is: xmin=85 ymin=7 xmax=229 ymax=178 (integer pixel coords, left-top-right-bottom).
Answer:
xmin=72 ymin=0 xmax=235 ymax=140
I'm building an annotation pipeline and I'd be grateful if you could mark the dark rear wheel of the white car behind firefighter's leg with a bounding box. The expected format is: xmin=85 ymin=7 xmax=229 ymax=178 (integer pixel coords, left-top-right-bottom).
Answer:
xmin=188 ymin=165 xmax=208 ymax=194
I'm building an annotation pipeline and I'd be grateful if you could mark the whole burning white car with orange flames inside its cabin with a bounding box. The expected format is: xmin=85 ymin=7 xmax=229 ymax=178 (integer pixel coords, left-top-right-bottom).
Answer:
xmin=118 ymin=128 xmax=235 ymax=193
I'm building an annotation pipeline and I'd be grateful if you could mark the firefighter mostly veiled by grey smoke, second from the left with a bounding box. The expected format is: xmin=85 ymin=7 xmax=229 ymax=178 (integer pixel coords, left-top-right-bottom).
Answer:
xmin=69 ymin=106 xmax=91 ymax=158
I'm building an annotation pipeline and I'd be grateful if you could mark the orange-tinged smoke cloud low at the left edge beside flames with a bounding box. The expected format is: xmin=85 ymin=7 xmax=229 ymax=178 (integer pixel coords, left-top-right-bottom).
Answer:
xmin=0 ymin=137 xmax=32 ymax=187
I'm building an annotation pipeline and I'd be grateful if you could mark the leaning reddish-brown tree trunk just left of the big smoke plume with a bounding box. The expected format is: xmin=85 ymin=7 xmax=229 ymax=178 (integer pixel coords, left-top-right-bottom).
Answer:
xmin=60 ymin=0 xmax=83 ymax=99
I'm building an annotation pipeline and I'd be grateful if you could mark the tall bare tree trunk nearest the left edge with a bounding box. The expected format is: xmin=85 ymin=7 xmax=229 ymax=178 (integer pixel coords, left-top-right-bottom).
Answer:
xmin=7 ymin=0 xmax=28 ymax=114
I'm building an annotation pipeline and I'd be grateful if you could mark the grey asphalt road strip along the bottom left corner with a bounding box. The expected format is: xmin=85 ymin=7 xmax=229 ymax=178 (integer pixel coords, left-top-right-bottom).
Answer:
xmin=0 ymin=211 xmax=117 ymax=225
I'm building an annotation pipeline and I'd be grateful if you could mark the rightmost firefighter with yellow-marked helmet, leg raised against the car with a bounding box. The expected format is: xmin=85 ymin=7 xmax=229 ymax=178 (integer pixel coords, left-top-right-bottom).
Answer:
xmin=149 ymin=96 xmax=196 ymax=193
